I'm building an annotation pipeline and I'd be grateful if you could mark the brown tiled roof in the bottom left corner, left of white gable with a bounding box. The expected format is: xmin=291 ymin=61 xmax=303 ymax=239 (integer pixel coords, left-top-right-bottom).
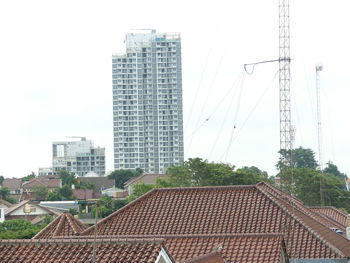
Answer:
xmin=0 ymin=239 xmax=166 ymax=263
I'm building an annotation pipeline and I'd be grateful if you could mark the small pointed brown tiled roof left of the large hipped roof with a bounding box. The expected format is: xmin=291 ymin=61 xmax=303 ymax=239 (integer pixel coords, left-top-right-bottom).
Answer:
xmin=33 ymin=213 xmax=87 ymax=239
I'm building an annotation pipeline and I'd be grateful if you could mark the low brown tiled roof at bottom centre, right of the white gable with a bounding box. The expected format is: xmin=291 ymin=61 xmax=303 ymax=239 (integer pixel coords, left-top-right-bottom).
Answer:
xmin=165 ymin=234 xmax=284 ymax=263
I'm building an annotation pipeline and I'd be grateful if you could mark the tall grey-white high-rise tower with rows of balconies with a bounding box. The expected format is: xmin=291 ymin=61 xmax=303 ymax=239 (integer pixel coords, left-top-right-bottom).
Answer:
xmin=112 ymin=30 xmax=184 ymax=173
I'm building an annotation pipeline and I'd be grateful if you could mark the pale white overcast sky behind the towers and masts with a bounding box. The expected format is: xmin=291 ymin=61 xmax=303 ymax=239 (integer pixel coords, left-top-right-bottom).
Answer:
xmin=0 ymin=0 xmax=350 ymax=178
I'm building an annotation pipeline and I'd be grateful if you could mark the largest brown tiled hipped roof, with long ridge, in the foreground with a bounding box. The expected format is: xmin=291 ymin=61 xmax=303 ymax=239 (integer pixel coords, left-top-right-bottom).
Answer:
xmin=81 ymin=183 xmax=350 ymax=258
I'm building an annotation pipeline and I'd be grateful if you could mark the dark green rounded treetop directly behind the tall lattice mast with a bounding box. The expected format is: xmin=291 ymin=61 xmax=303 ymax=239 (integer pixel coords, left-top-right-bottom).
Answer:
xmin=276 ymin=147 xmax=318 ymax=171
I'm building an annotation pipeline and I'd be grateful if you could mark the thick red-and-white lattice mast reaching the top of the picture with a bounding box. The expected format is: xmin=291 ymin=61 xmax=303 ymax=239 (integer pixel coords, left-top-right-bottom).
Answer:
xmin=279 ymin=0 xmax=292 ymax=166
